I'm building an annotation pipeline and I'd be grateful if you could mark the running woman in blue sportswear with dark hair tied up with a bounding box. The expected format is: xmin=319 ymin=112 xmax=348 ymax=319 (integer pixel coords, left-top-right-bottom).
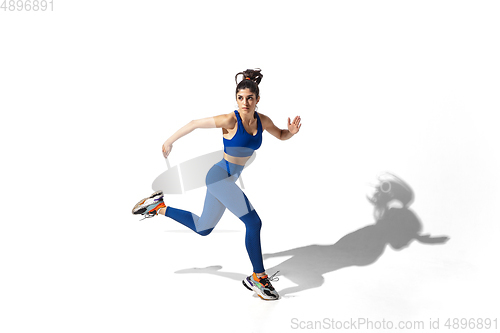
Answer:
xmin=132 ymin=69 xmax=301 ymax=300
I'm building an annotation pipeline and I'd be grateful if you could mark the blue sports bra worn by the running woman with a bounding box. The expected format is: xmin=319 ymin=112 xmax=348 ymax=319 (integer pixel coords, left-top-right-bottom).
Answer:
xmin=223 ymin=111 xmax=262 ymax=157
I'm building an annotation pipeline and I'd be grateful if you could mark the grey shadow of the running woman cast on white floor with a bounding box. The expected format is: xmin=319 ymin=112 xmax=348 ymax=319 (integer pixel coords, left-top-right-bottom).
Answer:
xmin=175 ymin=175 xmax=449 ymax=296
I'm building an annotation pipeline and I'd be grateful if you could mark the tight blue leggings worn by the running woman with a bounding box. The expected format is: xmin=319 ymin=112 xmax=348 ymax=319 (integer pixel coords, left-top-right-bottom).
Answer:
xmin=165 ymin=159 xmax=265 ymax=273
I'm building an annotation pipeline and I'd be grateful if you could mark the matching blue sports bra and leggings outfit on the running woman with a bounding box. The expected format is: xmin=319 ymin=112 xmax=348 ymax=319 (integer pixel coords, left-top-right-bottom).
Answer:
xmin=165 ymin=111 xmax=265 ymax=273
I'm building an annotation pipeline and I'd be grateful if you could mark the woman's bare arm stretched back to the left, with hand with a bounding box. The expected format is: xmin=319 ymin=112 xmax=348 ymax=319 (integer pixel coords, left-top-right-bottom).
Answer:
xmin=162 ymin=113 xmax=236 ymax=158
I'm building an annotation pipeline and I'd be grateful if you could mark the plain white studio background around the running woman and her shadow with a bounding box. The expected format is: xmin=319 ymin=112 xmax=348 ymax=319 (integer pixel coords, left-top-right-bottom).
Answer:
xmin=0 ymin=0 xmax=500 ymax=333
